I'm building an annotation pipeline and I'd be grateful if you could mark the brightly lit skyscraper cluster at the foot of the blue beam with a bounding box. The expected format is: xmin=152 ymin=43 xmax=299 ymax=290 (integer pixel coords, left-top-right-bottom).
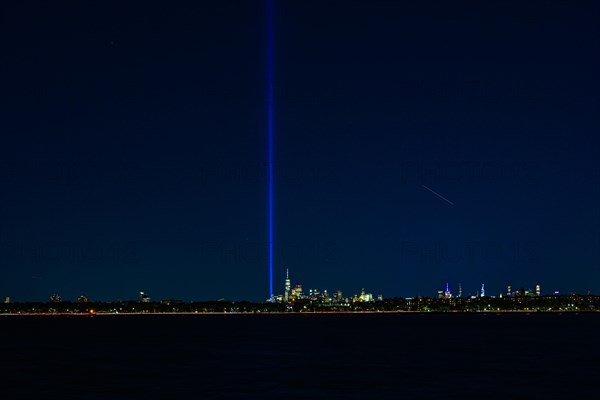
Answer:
xmin=267 ymin=269 xmax=383 ymax=304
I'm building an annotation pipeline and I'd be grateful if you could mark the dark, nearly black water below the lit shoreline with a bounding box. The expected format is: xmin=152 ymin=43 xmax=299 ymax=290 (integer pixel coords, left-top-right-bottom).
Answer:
xmin=0 ymin=314 xmax=600 ymax=400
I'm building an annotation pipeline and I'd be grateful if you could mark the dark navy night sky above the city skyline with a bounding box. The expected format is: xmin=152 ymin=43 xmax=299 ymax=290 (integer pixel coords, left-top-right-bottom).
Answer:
xmin=0 ymin=0 xmax=600 ymax=301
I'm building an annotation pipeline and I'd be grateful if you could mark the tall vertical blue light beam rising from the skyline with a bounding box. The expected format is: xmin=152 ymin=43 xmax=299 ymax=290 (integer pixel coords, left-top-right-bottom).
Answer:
xmin=267 ymin=0 xmax=274 ymax=301
